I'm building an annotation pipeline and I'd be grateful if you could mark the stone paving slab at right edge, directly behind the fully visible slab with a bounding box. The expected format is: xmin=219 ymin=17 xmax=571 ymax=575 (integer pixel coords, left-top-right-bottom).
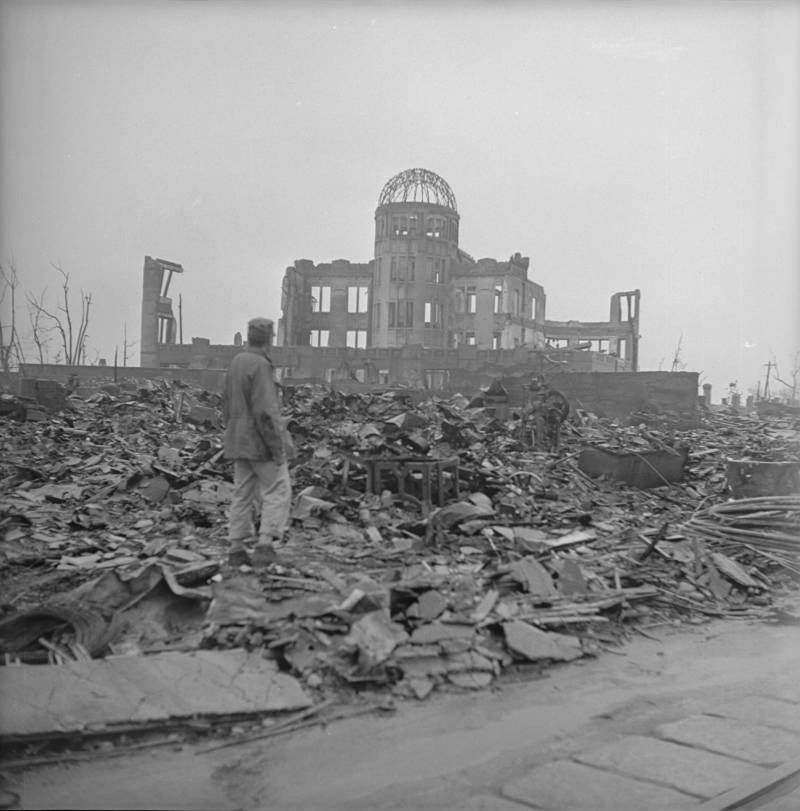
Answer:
xmin=658 ymin=715 xmax=800 ymax=766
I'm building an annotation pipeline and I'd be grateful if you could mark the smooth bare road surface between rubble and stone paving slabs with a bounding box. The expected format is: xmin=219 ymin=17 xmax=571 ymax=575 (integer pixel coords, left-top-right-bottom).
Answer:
xmin=5 ymin=621 xmax=800 ymax=811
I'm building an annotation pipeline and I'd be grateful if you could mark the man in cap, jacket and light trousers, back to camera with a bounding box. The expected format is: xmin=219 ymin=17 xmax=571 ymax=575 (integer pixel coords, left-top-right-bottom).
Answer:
xmin=222 ymin=318 xmax=292 ymax=566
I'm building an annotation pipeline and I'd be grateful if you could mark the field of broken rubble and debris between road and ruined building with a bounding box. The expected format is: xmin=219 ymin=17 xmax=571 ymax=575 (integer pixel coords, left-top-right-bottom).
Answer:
xmin=0 ymin=380 xmax=800 ymax=762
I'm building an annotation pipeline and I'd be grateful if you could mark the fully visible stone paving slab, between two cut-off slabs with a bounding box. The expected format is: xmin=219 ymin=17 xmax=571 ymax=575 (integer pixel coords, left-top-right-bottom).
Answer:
xmin=575 ymin=735 xmax=767 ymax=797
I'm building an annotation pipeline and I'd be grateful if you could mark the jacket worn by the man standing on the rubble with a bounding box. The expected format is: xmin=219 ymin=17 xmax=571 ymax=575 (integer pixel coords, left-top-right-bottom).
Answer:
xmin=222 ymin=346 xmax=286 ymax=464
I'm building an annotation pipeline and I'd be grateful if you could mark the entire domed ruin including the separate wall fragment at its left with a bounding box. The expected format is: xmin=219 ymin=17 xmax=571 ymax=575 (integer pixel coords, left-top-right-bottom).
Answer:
xmin=141 ymin=169 xmax=640 ymax=389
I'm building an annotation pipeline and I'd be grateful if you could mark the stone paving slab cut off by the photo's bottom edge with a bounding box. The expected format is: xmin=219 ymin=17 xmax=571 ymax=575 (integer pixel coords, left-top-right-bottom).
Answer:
xmin=502 ymin=760 xmax=698 ymax=811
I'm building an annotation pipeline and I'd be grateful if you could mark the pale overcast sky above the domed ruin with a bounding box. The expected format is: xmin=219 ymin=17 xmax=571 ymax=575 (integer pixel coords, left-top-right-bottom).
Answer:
xmin=0 ymin=0 xmax=800 ymax=401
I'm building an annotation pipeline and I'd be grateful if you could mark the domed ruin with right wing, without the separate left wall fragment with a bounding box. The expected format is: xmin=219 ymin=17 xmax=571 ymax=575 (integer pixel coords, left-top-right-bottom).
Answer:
xmin=278 ymin=169 xmax=639 ymax=370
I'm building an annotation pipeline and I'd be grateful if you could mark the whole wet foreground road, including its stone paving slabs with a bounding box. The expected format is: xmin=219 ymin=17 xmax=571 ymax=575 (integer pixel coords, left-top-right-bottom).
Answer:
xmin=6 ymin=622 xmax=800 ymax=811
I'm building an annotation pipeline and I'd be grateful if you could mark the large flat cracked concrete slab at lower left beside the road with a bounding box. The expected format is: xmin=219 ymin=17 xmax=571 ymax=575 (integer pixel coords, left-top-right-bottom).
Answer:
xmin=0 ymin=650 xmax=311 ymax=736
